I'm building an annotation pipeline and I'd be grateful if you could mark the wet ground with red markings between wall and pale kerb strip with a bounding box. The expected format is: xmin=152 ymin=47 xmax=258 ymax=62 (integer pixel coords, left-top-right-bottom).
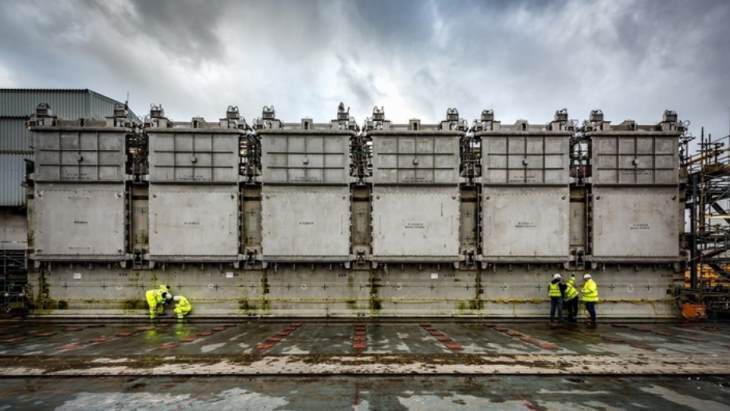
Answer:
xmin=0 ymin=320 xmax=730 ymax=358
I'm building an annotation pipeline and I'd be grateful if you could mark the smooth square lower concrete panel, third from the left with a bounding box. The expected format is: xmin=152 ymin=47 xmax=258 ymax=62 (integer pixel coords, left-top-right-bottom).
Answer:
xmin=261 ymin=185 xmax=350 ymax=261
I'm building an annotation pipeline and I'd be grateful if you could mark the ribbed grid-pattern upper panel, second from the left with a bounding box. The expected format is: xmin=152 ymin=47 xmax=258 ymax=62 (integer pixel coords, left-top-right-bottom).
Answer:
xmin=147 ymin=132 xmax=242 ymax=183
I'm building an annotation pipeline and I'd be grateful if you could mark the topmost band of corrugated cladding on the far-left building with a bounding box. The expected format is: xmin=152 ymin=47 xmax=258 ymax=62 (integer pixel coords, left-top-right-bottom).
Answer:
xmin=0 ymin=89 xmax=137 ymax=120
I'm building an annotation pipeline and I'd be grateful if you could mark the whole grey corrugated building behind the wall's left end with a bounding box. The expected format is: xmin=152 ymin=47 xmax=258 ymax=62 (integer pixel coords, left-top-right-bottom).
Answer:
xmin=0 ymin=89 xmax=136 ymax=306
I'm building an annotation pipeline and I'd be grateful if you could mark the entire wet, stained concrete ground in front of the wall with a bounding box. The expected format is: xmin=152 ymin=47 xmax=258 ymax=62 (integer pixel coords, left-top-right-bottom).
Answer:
xmin=0 ymin=319 xmax=730 ymax=410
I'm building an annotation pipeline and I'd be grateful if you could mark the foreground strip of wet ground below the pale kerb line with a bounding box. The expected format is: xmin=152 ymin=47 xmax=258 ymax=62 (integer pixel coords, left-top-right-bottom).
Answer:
xmin=0 ymin=376 xmax=730 ymax=411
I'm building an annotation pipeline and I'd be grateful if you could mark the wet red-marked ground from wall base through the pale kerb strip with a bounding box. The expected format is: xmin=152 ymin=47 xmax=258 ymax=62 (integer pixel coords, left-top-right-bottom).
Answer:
xmin=0 ymin=320 xmax=730 ymax=376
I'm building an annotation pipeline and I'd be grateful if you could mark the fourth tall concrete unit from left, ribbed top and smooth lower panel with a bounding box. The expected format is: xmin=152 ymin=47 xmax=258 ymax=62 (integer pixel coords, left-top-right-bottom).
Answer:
xmin=366 ymin=108 xmax=467 ymax=263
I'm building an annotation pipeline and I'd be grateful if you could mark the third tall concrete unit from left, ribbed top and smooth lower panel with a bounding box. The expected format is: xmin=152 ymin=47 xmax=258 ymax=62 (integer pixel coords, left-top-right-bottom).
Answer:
xmin=255 ymin=107 xmax=358 ymax=263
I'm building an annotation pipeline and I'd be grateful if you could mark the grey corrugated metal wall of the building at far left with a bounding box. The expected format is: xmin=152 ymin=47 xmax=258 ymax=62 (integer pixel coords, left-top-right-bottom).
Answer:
xmin=0 ymin=89 xmax=132 ymax=207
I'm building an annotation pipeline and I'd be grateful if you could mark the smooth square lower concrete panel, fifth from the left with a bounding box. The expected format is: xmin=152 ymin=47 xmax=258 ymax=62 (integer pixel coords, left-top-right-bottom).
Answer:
xmin=482 ymin=187 xmax=570 ymax=262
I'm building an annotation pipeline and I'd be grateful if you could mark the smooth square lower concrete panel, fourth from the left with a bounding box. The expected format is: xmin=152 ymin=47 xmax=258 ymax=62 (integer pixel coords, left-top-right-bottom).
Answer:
xmin=373 ymin=186 xmax=460 ymax=261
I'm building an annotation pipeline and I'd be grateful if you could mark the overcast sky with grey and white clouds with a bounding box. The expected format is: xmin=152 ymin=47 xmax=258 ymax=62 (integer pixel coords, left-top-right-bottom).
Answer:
xmin=0 ymin=0 xmax=730 ymax=136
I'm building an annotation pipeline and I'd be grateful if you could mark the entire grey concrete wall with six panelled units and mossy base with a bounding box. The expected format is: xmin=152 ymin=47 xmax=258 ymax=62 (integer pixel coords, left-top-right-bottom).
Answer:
xmin=21 ymin=105 xmax=683 ymax=317
